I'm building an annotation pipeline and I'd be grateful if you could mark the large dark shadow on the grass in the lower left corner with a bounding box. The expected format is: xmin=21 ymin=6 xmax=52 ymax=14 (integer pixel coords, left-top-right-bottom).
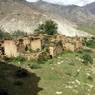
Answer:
xmin=0 ymin=62 xmax=42 ymax=95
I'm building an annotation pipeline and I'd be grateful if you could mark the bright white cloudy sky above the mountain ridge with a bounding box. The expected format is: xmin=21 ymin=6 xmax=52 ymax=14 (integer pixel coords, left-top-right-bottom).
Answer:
xmin=26 ymin=0 xmax=95 ymax=6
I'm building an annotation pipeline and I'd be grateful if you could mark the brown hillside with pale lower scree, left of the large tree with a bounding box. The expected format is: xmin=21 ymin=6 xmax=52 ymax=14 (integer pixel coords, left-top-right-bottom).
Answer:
xmin=0 ymin=0 xmax=46 ymax=33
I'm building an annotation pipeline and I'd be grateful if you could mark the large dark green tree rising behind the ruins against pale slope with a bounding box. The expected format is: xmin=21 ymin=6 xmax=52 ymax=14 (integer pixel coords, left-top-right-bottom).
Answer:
xmin=35 ymin=20 xmax=58 ymax=35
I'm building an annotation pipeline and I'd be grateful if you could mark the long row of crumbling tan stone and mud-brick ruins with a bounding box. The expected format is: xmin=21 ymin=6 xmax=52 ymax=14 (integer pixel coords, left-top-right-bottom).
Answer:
xmin=0 ymin=34 xmax=83 ymax=60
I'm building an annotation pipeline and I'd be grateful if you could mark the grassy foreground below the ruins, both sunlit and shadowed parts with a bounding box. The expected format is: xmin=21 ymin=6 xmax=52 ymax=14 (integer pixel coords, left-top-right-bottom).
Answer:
xmin=0 ymin=51 xmax=95 ymax=95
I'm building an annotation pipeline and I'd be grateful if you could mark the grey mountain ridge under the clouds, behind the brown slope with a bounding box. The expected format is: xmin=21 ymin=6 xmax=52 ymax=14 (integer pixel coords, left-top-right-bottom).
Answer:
xmin=31 ymin=1 xmax=95 ymax=25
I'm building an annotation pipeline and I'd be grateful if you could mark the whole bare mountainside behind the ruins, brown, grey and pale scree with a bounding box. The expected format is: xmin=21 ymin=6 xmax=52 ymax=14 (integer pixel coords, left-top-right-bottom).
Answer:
xmin=0 ymin=0 xmax=95 ymax=36
